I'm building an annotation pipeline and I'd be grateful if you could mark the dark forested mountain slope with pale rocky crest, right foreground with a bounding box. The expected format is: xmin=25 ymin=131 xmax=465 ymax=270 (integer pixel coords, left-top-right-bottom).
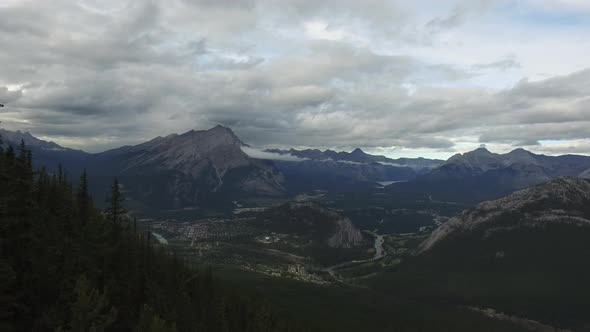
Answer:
xmin=400 ymin=177 xmax=590 ymax=331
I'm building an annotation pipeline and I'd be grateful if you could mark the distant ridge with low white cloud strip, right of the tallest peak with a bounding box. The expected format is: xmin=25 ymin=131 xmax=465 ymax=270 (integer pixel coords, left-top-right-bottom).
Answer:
xmin=266 ymin=149 xmax=442 ymax=191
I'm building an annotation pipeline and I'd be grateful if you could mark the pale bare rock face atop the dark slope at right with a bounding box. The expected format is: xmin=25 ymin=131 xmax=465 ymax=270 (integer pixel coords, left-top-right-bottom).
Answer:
xmin=420 ymin=177 xmax=590 ymax=252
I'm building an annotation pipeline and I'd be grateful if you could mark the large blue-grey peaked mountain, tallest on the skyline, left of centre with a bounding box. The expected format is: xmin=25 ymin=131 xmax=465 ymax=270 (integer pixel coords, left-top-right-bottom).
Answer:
xmin=92 ymin=126 xmax=285 ymax=208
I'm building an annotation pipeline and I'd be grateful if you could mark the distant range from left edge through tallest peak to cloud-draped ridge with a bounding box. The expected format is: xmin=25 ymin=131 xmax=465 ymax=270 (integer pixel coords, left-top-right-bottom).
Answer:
xmin=1 ymin=126 xmax=440 ymax=209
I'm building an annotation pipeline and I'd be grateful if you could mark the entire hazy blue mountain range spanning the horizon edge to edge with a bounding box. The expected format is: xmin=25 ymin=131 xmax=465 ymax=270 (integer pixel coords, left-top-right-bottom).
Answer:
xmin=0 ymin=126 xmax=590 ymax=209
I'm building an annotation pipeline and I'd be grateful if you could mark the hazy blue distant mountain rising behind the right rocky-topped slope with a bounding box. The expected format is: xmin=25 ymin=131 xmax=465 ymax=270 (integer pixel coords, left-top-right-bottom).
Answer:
xmin=388 ymin=148 xmax=590 ymax=204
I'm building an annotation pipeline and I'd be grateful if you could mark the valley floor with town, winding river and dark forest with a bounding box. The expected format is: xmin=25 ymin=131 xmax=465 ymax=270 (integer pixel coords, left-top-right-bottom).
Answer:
xmin=135 ymin=187 xmax=590 ymax=332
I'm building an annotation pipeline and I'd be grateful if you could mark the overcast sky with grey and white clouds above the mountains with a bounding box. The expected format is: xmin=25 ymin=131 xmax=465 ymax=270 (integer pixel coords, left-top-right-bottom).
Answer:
xmin=0 ymin=0 xmax=590 ymax=158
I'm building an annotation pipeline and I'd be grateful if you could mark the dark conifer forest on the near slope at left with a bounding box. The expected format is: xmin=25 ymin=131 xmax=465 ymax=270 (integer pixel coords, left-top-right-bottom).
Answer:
xmin=0 ymin=140 xmax=299 ymax=332
